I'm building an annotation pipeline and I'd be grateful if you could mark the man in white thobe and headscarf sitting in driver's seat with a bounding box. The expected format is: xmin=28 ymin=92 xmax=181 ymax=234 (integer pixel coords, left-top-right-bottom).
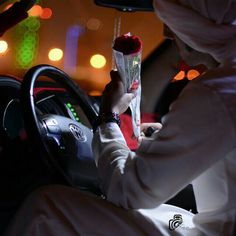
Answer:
xmin=3 ymin=0 xmax=236 ymax=236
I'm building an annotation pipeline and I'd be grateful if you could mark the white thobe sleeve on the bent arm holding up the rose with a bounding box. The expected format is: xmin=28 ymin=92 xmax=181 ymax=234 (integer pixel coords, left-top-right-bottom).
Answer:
xmin=93 ymin=83 xmax=235 ymax=209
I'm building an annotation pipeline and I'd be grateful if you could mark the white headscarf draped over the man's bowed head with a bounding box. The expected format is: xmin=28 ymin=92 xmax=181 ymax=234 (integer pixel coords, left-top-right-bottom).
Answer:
xmin=153 ymin=0 xmax=236 ymax=62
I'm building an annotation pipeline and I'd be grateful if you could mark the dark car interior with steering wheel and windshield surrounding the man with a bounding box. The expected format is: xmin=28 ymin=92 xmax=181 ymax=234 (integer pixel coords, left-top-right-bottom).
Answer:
xmin=0 ymin=0 xmax=201 ymax=234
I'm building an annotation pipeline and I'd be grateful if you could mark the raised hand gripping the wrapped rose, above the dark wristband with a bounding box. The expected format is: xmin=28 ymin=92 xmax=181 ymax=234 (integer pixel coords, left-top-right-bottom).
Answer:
xmin=100 ymin=71 xmax=135 ymax=114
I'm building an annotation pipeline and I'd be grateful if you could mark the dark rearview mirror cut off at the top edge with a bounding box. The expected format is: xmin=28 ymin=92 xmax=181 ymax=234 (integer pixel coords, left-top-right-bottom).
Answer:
xmin=94 ymin=0 xmax=153 ymax=12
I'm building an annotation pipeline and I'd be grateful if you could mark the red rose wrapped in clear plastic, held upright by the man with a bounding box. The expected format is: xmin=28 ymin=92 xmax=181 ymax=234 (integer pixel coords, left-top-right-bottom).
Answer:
xmin=113 ymin=34 xmax=142 ymax=138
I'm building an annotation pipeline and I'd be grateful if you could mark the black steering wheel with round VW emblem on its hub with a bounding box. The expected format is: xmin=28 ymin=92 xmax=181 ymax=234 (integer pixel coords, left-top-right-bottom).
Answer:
xmin=20 ymin=64 xmax=100 ymax=194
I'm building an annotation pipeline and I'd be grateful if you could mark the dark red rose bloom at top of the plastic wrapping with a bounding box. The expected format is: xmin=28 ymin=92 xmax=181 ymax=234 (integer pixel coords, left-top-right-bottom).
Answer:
xmin=113 ymin=34 xmax=142 ymax=55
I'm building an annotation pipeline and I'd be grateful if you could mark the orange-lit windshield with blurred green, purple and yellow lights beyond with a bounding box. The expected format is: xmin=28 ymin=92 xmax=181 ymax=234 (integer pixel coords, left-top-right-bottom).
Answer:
xmin=0 ymin=0 xmax=163 ymax=95
